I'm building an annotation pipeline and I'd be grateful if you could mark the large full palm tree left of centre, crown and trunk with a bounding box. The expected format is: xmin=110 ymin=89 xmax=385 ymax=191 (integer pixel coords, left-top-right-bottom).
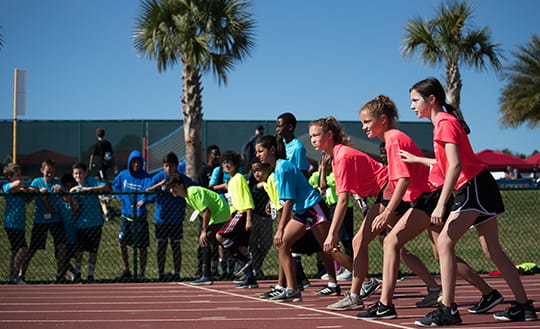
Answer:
xmin=133 ymin=0 xmax=255 ymax=177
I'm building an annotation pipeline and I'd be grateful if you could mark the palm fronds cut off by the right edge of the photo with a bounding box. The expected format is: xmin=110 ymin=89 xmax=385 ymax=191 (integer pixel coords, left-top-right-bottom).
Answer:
xmin=499 ymin=35 xmax=540 ymax=128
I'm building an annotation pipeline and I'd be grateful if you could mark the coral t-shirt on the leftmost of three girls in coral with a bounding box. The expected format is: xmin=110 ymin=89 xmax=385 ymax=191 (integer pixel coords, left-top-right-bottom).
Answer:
xmin=332 ymin=144 xmax=388 ymax=197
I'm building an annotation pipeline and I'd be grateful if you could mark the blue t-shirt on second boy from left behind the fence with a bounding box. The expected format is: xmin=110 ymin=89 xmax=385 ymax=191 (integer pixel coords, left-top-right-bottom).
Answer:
xmin=30 ymin=177 xmax=64 ymax=223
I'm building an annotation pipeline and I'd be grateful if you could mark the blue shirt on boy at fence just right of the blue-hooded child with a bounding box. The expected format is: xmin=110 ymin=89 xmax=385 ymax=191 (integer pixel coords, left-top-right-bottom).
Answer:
xmin=149 ymin=170 xmax=197 ymax=224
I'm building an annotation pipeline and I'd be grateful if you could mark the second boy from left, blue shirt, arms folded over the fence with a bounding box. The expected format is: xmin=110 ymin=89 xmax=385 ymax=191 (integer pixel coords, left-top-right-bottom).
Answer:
xmin=22 ymin=160 xmax=66 ymax=282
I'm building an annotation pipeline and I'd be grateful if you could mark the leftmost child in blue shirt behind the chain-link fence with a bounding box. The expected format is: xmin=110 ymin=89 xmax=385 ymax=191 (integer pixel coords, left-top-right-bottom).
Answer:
xmin=2 ymin=163 xmax=29 ymax=284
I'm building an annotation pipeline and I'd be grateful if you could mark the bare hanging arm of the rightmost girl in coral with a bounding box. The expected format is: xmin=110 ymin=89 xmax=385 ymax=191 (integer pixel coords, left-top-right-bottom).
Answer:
xmin=431 ymin=143 xmax=461 ymax=225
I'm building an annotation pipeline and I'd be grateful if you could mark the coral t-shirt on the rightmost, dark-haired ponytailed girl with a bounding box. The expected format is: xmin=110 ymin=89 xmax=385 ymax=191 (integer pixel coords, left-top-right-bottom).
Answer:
xmin=433 ymin=112 xmax=487 ymax=190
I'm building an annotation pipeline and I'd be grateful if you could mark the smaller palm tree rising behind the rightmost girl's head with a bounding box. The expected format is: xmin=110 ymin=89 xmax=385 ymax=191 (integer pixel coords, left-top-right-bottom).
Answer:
xmin=402 ymin=1 xmax=502 ymax=118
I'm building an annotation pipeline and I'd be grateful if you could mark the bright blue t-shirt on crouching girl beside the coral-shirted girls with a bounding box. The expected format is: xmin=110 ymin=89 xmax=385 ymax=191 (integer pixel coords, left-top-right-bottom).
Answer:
xmin=274 ymin=159 xmax=322 ymax=214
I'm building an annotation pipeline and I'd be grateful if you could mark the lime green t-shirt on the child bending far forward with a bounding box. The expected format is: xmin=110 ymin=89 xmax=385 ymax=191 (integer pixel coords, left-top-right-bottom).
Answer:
xmin=186 ymin=186 xmax=231 ymax=225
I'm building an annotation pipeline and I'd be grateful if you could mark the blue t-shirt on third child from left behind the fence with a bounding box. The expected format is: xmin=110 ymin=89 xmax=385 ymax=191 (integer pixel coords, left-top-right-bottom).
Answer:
xmin=75 ymin=176 xmax=105 ymax=228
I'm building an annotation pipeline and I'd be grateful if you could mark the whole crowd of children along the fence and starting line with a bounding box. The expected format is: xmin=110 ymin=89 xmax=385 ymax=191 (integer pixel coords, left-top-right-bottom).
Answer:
xmin=3 ymin=79 xmax=537 ymax=327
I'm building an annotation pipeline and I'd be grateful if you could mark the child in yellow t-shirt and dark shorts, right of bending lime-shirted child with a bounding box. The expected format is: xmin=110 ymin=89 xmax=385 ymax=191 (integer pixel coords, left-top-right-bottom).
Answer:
xmin=216 ymin=151 xmax=259 ymax=288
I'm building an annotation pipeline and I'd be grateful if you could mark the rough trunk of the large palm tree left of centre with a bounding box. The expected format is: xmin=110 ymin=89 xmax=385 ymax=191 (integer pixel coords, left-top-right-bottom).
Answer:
xmin=181 ymin=61 xmax=203 ymax=179
